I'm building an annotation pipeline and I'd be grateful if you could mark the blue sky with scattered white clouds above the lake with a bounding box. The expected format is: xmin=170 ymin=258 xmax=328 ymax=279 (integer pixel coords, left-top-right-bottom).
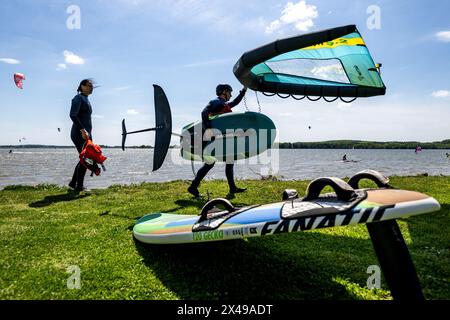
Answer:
xmin=0 ymin=0 xmax=450 ymax=145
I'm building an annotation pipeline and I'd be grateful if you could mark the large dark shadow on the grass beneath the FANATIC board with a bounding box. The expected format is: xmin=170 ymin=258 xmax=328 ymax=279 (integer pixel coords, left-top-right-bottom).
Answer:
xmin=135 ymin=232 xmax=376 ymax=300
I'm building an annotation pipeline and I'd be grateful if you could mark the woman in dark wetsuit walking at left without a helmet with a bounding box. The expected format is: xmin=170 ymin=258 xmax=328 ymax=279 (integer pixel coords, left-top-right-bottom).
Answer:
xmin=69 ymin=79 xmax=94 ymax=191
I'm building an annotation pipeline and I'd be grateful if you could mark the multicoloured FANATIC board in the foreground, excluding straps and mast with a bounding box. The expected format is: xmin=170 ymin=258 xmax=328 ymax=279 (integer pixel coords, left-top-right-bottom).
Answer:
xmin=133 ymin=189 xmax=440 ymax=244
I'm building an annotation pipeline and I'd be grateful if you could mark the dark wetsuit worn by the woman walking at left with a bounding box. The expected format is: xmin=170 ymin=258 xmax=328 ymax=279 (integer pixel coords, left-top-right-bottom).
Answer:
xmin=69 ymin=94 xmax=92 ymax=188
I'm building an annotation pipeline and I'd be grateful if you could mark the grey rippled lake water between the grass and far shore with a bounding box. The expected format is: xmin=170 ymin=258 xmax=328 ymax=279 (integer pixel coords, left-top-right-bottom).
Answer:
xmin=0 ymin=148 xmax=450 ymax=189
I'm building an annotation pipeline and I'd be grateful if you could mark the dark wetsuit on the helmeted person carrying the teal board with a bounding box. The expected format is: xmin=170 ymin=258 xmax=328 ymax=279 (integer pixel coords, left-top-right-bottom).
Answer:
xmin=191 ymin=90 xmax=245 ymax=190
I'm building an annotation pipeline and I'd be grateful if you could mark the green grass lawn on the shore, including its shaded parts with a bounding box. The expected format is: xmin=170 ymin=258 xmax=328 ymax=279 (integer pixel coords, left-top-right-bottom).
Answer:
xmin=0 ymin=177 xmax=450 ymax=299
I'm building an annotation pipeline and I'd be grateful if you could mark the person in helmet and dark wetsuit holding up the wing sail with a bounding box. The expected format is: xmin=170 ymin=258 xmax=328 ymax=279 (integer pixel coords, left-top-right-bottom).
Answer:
xmin=188 ymin=84 xmax=247 ymax=197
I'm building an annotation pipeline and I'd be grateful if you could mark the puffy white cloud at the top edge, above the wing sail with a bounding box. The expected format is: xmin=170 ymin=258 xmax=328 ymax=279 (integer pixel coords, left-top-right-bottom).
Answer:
xmin=266 ymin=0 xmax=319 ymax=33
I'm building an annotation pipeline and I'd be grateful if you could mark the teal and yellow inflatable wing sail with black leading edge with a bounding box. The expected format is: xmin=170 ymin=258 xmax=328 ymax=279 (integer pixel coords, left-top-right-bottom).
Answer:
xmin=233 ymin=25 xmax=386 ymax=101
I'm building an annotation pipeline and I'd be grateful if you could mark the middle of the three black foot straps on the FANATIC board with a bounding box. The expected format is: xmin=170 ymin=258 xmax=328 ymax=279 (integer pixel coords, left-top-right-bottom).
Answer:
xmin=302 ymin=177 xmax=356 ymax=201
